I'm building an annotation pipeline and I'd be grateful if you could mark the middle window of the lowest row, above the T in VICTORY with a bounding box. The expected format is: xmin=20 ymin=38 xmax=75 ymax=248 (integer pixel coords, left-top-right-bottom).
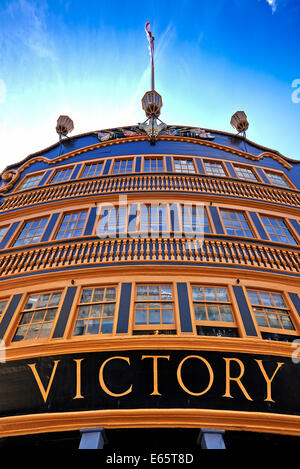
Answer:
xmin=134 ymin=285 xmax=175 ymax=334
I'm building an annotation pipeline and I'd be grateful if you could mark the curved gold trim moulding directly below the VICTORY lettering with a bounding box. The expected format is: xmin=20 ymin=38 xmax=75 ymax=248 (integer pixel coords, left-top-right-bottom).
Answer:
xmin=0 ymin=409 xmax=300 ymax=438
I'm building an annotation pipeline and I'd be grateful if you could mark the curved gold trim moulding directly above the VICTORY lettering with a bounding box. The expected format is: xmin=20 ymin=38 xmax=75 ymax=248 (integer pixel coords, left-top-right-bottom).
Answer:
xmin=5 ymin=333 xmax=295 ymax=362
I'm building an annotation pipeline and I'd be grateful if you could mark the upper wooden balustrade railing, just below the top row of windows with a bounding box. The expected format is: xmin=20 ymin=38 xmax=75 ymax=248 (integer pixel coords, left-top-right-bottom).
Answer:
xmin=0 ymin=174 xmax=300 ymax=211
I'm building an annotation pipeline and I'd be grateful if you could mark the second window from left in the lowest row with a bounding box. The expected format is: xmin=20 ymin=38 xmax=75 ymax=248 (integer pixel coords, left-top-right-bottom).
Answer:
xmin=73 ymin=286 xmax=116 ymax=336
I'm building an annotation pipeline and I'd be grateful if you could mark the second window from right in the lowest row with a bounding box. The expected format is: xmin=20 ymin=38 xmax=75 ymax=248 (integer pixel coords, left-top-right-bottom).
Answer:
xmin=192 ymin=285 xmax=237 ymax=337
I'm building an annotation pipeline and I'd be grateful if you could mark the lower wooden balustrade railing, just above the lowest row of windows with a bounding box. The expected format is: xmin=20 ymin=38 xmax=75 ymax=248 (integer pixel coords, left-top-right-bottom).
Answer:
xmin=0 ymin=238 xmax=300 ymax=277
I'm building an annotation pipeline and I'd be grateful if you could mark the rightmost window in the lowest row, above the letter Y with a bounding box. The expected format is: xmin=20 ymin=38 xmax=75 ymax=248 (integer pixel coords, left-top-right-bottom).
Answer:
xmin=247 ymin=290 xmax=295 ymax=340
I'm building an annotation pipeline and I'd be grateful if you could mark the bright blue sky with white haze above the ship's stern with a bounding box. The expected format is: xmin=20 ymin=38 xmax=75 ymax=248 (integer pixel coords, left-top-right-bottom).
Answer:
xmin=0 ymin=0 xmax=300 ymax=171
